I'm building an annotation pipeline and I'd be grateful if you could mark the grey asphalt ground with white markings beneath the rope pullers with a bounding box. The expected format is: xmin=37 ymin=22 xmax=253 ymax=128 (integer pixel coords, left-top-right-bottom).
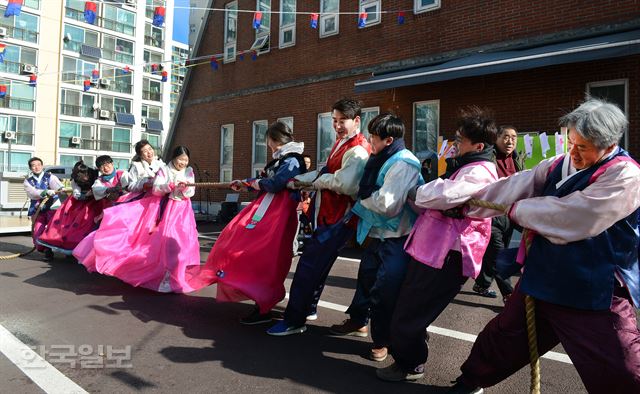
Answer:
xmin=0 ymin=226 xmax=585 ymax=394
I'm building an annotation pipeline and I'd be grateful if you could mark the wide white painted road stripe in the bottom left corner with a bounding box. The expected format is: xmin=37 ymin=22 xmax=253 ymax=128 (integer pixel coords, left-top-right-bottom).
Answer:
xmin=0 ymin=325 xmax=88 ymax=394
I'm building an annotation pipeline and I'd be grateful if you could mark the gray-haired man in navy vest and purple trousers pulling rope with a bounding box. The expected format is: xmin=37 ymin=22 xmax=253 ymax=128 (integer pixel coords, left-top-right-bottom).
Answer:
xmin=429 ymin=99 xmax=640 ymax=393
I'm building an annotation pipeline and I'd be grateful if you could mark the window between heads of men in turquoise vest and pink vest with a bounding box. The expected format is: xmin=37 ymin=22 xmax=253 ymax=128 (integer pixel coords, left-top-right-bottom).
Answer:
xmin=413 ymin=100 xmax=440 ymax=153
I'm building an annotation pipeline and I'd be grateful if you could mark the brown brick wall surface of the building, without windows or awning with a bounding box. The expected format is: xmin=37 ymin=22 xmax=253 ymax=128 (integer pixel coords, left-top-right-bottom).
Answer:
xmin=172 ymin=0 xmax=640 ymax=201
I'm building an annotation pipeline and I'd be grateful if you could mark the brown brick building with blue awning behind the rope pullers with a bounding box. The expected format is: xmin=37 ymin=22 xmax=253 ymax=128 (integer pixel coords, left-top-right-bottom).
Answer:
xmin=167 ymin=0 xmax=640 ymax=201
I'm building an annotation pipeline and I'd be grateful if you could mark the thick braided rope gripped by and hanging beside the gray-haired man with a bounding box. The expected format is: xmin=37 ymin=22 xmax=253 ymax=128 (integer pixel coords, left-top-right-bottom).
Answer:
xmin=467 ymin=198 xmax=540 ymax=394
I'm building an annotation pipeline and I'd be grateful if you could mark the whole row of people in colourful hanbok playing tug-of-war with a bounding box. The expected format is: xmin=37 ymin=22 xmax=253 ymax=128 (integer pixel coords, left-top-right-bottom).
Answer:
xmin=24 ymin=98 xmax=640 ymax=393
